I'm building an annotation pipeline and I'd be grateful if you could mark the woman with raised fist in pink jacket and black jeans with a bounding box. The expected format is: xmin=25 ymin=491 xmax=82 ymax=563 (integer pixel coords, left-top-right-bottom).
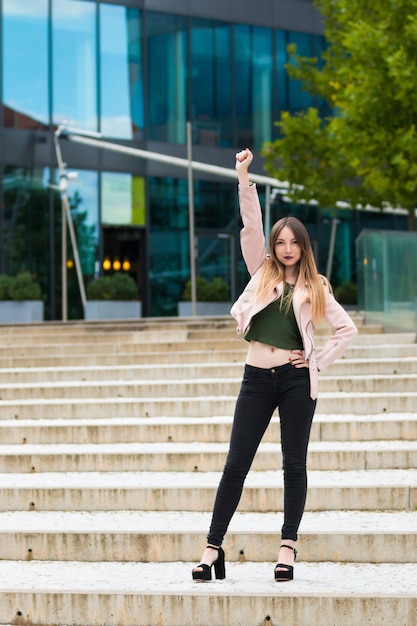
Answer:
xmin=192 ymin=149 xmax=357 ymax=581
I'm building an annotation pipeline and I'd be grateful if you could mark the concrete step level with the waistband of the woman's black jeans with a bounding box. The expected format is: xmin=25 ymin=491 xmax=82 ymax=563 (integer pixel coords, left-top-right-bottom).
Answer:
xmin=0 ymin=357 xmax=417 ymax=387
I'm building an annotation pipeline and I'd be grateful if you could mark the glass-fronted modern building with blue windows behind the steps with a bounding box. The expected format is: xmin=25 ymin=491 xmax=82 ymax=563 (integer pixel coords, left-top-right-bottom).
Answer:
xmin=0 ymin=0 xmax=406 ymax=319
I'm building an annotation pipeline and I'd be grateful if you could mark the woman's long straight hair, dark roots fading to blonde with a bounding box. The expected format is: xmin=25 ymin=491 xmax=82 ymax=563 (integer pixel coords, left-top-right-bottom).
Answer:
xmin=255 ymin=216 xmax=331 ymax=322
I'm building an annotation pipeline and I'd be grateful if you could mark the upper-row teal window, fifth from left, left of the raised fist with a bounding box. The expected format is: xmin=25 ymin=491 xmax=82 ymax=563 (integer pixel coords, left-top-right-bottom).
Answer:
xmin=191 ymin=20 xmax=232 ymax=146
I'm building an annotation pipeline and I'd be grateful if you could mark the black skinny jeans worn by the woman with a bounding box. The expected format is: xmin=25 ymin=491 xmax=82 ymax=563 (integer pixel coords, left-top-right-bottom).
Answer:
xmin=207 ymin=363 xmax=316 ymax=546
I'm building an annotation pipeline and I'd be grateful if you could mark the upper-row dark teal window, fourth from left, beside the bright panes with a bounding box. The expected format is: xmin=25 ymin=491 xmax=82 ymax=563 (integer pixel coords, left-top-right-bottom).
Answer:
xmin=146 ymin=12 xmax=187 ymax=143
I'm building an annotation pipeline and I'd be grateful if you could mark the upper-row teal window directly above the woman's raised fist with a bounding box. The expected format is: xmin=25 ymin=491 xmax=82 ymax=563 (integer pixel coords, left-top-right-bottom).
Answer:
xmin=234 ymin=25 xmax=273 ymax=149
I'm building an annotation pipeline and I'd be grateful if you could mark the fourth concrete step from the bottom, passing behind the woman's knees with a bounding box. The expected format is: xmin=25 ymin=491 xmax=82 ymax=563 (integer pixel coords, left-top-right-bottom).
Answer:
xmin=0 ymin=441 xmax=417 ymax=473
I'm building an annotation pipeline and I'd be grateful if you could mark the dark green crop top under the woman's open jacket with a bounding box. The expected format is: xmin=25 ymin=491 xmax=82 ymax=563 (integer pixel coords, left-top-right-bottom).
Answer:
xmin=245 ymin=283 xmax=303 ymax=350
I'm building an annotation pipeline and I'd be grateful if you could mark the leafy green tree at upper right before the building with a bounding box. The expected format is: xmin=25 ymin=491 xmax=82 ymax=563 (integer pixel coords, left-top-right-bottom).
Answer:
xmin=262 ymin=0 xmax=417 ymax=230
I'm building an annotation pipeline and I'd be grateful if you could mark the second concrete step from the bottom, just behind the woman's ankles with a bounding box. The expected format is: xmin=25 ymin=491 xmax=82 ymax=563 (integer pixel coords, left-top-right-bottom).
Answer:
xmin=0 ymin=511 xmax=417 ymax=563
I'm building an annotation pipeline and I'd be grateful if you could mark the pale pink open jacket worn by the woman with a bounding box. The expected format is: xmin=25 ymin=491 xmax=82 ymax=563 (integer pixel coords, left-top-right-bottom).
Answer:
xmin=230 ymin=185 xmax=358 ymax=399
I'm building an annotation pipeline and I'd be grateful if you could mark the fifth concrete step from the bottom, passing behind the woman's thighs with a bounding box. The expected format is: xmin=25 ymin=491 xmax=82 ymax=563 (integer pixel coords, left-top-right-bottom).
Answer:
xmin=0 ymin=413 xmax=417 ymax=444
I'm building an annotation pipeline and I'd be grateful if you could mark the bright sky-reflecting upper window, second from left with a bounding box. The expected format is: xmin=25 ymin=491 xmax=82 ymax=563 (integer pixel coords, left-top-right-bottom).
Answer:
xmin=52 ymin=0 xmax=98 ymax=131
